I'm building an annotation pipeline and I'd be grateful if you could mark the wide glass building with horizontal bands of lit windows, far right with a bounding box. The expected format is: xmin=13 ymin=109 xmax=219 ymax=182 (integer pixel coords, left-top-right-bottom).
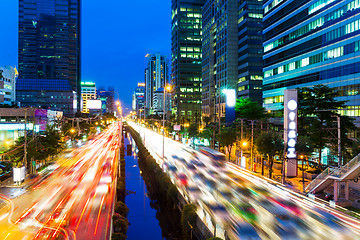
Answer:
xmin=263 ymin=0 xmax=360 ymax=122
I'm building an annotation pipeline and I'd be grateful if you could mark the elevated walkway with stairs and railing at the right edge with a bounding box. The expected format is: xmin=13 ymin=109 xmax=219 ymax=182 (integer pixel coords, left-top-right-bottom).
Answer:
xmin=305 ymin=154 xmax=360 ymax=201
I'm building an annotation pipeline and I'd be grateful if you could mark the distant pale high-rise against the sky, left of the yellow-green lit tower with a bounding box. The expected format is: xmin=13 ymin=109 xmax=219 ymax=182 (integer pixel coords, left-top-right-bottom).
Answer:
xmin=145 ymin=53 xmax=169 ymax=115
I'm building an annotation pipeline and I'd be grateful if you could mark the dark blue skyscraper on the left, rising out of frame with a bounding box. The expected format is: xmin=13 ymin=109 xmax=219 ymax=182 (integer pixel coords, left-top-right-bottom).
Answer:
xmin=17 ymin=0 xmax=81 ymax=115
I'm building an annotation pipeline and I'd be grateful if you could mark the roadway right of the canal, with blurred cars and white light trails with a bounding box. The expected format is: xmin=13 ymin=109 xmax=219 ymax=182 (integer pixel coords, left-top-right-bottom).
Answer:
xmin=128 ymin=122 xmax=360 ymax=240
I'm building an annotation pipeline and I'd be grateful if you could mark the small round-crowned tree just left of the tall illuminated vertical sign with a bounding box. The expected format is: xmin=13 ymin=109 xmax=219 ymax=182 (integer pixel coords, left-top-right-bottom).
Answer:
xmin=255 ymin=133 xmax=284 ymax=178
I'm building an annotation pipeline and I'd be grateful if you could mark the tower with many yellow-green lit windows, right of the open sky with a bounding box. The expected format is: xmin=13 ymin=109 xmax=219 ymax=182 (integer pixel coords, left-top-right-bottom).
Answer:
xmin=170 ymin=0 xmax=205 ymax=123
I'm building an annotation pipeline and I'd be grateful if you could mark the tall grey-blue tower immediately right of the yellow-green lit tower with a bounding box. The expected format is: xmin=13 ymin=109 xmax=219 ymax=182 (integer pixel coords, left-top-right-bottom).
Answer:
xmin=202 ymin=0 xmax=238 ymax=121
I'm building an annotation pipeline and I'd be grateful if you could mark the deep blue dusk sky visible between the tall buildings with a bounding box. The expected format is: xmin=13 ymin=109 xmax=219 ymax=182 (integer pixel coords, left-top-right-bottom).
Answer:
xmin=0 ymin=0 xmax=171 ymax=109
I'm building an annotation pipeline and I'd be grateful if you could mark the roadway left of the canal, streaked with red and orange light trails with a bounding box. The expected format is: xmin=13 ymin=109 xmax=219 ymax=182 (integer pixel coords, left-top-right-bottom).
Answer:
xmin=0 ymin=123 xmax=120 ymax=240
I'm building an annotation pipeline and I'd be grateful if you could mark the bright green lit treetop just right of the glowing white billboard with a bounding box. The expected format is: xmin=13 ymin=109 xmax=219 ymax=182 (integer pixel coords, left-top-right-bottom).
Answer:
xmin=235 ymin=97 xmax=267 ymax=119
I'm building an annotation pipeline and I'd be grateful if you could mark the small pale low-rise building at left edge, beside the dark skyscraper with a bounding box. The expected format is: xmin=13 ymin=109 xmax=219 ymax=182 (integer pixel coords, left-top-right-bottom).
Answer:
xmin=0 ymin=66 xmax=18 ymax=106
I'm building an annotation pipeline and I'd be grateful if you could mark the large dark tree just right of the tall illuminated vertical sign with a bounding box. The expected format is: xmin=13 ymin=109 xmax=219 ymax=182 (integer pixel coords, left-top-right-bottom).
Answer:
xmin=298 ymin=85 xmax=355 ymax=165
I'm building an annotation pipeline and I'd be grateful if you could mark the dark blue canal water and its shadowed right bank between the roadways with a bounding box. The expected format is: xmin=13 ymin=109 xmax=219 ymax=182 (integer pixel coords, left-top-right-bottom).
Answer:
xmin=125 ymin=136 xmax=181 ymax=240
